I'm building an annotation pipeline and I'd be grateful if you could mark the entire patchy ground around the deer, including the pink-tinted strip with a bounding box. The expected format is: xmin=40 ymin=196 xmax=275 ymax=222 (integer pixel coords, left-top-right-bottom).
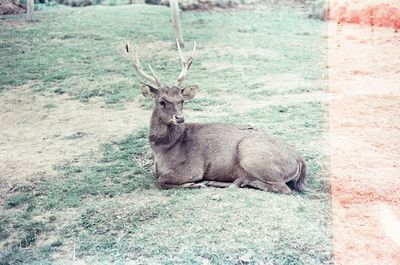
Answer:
xmin=0 ymin=2 xmax=399 ymax=264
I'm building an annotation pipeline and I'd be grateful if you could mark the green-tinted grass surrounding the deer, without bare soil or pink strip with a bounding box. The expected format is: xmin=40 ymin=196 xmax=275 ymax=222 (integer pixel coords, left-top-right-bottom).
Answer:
xmin=0 ymin=5 xmax=333 ymax=264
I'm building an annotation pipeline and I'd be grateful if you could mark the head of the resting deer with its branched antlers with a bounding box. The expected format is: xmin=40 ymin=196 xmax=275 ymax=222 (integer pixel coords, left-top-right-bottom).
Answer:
xmin=126 ymin=41 xmax=198 ymax=125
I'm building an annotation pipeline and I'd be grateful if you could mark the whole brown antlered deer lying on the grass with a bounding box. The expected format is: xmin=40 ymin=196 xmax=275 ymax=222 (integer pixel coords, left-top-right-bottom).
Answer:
xmin=125 ymin=41 xmax=307 ymax=194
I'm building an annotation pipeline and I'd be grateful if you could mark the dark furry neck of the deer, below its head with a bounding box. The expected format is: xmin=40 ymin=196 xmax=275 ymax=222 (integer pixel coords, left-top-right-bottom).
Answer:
xmin=149 ymin=109 xmax=185 ymax=149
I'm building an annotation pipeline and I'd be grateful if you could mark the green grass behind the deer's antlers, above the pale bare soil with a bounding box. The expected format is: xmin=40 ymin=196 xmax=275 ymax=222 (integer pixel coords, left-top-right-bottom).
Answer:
xmin=0 ymin=5 xmax=324 ymax=104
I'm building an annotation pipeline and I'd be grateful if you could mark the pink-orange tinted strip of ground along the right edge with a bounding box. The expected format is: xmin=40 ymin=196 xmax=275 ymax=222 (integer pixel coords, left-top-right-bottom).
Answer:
xmin=329 ymin=22 xmax=400 ymax=264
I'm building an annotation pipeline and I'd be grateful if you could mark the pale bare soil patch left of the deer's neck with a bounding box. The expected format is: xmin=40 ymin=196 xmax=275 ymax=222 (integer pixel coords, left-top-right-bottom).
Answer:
xmin=0 ymin=85 xmax=150 ymax=195
